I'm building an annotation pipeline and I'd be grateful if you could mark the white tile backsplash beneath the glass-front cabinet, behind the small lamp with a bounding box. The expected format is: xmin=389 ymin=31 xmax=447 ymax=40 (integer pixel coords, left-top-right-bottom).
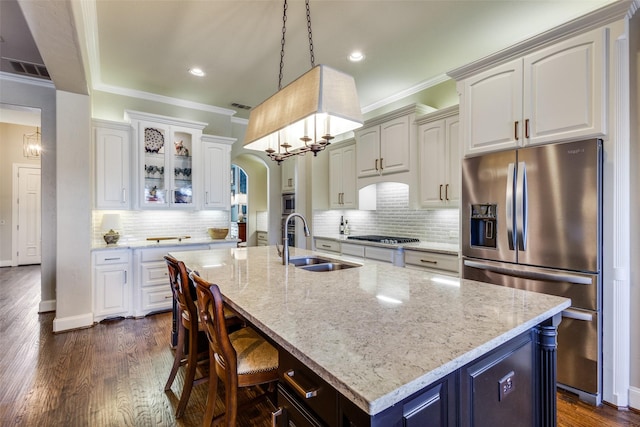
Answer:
xmin=92 ymin=211 xmax=229 ymax=245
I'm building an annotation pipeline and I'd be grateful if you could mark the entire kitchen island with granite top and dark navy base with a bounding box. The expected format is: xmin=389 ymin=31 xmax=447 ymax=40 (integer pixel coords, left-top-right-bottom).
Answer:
xmin=171 ymin=246 xmax=570 ymax=426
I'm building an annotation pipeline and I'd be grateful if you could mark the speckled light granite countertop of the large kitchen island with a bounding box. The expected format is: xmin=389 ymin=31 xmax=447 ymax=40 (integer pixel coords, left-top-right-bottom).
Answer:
xmin=171 ymin=246 xmax=570 ymax=415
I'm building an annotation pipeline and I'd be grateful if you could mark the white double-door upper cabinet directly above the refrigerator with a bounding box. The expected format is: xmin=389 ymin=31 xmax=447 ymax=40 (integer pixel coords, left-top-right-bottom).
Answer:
xmin=459 ymin=29 xmax=607 ymax=156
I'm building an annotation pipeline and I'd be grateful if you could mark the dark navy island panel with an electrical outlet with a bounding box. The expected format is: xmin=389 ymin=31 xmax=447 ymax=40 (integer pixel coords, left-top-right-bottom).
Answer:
xmin=460 ymin=334 xmax=537 ymax=427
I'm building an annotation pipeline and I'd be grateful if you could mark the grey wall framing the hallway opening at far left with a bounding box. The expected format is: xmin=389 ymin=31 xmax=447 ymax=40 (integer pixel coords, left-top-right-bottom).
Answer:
xmin=0 ymin=74 xmax=57 ymax=312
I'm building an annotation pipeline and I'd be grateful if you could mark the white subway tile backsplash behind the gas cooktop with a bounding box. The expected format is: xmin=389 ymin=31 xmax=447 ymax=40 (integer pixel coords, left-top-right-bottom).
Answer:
xmin=312 ymin=183 xmax=460 ymax=244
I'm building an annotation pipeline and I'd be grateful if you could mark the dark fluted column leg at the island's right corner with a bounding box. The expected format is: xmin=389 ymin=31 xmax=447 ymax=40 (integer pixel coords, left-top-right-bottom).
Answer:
xmin=537 ymin=313 xmax=562 ymax=427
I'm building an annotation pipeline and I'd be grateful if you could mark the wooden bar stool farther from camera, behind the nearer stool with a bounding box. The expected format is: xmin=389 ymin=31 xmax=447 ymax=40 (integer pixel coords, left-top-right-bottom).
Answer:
xmin=164 ymin=255 xmax=208 ymax=418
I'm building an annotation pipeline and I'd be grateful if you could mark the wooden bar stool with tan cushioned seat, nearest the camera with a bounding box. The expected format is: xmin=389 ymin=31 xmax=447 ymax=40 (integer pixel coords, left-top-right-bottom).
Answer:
xmin=190 ymin=273 xmax=278 ymax=427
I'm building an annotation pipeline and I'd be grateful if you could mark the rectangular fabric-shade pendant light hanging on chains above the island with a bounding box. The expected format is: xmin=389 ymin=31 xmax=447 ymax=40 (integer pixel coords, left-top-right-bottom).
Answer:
xmin=243 ymin=0 xmax=363 ymax=164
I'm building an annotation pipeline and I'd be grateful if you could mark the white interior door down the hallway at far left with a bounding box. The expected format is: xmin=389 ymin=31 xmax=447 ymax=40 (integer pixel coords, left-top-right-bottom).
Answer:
xmin=16 ymin=167 xmax=42 ymax=265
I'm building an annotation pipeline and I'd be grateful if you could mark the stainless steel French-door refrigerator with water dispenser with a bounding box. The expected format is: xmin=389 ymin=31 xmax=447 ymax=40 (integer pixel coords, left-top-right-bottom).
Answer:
xmin=461 ymin=139 xmax=602 ymax=404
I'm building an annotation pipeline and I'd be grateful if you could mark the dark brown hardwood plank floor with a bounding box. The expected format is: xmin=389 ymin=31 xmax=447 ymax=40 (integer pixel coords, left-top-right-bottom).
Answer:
xmin=0 ymin=266 xmax=640 ymax=427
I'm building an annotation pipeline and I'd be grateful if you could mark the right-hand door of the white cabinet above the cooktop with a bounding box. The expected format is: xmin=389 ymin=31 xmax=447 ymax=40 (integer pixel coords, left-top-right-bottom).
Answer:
xmin=380 ymin=116 xmax=411 ymax=174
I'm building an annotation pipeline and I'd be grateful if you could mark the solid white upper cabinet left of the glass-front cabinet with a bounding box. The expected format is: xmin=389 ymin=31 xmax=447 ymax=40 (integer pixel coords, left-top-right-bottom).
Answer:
xmin=93 ymin=120 xmax=131 ymax=209
